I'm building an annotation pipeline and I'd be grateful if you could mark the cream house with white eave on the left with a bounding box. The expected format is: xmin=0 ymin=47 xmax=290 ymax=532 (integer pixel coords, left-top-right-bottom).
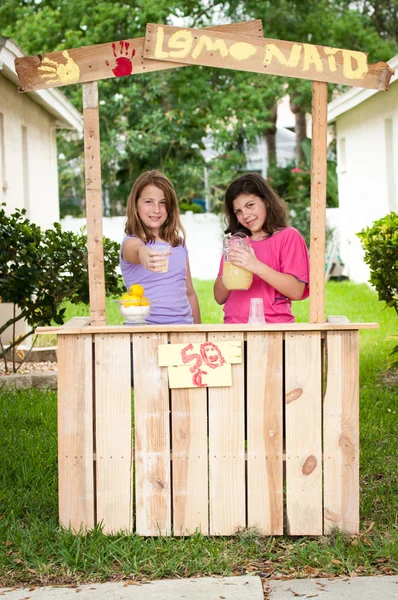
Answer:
xmin=0 ymin=35 xmax=83 ymax=344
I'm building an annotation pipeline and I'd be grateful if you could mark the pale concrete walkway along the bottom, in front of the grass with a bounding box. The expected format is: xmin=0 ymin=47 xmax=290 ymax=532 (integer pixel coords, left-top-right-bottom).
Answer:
xmin=0 ymin=575 xmax=398 ymax=600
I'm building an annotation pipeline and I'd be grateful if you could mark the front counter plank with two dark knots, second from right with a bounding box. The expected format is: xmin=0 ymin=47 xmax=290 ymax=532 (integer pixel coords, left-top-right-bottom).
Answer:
xmin=285 ymin=333 xmax=322 ymax=535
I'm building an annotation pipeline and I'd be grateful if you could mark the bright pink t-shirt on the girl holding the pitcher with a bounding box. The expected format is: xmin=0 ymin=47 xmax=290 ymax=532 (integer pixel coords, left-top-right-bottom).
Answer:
xmin=218 ymin=227 xmax=310 ymax=323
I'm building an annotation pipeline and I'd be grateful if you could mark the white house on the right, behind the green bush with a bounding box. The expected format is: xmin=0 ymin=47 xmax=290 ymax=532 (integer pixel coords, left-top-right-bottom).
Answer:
xmin=328 ymin=55 xmax=398 ymax=283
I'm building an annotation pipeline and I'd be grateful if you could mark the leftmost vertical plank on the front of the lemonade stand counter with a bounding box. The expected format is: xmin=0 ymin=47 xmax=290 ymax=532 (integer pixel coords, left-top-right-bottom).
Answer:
xmin=58 ymin=335 xmax=95 ymax=532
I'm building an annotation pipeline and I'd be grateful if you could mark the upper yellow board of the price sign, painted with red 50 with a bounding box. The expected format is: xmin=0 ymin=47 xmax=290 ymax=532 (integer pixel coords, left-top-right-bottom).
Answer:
xmin=159 ymin=341 xmax=242 ymax=367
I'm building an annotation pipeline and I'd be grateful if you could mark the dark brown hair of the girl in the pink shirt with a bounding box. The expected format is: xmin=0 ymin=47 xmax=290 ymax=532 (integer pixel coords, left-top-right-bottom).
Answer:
xmin=224 ymin=173 xmax=287 ymax=235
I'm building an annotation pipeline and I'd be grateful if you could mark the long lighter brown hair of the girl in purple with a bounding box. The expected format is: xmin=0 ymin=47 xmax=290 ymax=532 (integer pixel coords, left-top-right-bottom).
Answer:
xmin=125 ymin=171 xmax=185 ymax=248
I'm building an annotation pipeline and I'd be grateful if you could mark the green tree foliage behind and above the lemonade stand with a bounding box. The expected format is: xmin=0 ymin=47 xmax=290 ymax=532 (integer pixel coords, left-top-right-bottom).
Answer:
xmin=0 ymin=0 xmax=398 ymax=216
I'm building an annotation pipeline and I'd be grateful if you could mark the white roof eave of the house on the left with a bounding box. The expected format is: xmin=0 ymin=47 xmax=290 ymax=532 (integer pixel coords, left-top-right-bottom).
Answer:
xmin=0 ymin=35 xmax=83 ymax=133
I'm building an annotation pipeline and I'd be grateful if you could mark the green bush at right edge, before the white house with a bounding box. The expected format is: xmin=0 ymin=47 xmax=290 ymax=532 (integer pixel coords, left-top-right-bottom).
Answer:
xmin=357 ymin=212 xmax=398 ymax=367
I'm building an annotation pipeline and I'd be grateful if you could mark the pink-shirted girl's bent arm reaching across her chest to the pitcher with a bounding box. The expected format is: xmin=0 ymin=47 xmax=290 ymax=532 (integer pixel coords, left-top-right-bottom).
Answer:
xmin=228 ymin=248 xmax=305 ymax=300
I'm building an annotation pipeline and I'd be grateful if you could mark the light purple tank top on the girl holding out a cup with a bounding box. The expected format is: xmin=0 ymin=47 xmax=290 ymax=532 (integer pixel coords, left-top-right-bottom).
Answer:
xmin=120 ymin=236 xmax=193 ymax=325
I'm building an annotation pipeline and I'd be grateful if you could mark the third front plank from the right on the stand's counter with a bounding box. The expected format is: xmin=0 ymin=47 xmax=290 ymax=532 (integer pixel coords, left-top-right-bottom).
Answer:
xmin=247 ymin=332 xmax=283 ymax=535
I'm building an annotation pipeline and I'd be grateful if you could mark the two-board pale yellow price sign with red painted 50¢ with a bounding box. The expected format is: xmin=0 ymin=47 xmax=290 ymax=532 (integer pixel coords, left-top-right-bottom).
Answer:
xmin=158 ymin=342 xmax=242 ymax=388
